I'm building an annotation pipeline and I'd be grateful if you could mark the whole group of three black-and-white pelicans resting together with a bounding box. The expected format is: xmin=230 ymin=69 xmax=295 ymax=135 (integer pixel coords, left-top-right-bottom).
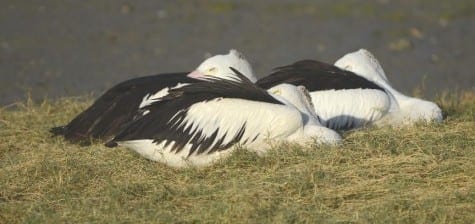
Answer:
xmin=50 ymin=49 xmax=442 ymax=168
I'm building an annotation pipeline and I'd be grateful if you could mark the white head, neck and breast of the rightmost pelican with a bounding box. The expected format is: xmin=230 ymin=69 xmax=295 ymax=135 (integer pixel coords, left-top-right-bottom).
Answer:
xmin=335 ymin=49 xmax=442 ymax=126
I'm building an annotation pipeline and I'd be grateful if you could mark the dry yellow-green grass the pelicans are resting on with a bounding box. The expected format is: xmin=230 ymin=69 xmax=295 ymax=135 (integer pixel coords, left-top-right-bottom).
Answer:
xmin=0 ymin=93 xmax=475 ymax=223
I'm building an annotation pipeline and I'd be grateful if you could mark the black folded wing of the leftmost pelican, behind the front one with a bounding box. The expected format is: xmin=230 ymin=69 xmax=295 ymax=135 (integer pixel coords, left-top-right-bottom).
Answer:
xmin=51 ymin=73 xmax=196 ymax=141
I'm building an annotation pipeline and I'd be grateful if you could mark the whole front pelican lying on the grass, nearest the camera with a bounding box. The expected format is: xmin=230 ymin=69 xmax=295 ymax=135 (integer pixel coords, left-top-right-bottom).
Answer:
xmin=107 ymin=70 xmax=341 ymax=167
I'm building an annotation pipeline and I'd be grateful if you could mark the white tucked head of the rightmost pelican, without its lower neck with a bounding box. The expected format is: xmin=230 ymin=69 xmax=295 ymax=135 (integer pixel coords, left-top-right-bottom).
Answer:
xmin=335 ymin=49 xmax=389 ymax=83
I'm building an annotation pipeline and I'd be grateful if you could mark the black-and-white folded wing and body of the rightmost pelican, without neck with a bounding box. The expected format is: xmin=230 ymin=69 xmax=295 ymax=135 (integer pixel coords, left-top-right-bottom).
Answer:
xmin=257 ymin=60 xmax=390 ymax=130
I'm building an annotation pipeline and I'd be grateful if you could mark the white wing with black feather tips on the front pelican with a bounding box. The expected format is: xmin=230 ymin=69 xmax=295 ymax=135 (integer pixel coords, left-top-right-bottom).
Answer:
xmin=109 ymin=96 xmax=303 ymax=156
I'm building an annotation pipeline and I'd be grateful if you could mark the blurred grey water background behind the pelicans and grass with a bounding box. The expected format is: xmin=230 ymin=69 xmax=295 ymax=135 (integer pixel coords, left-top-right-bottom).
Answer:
xmin=0 ymin=0 xmax=475 ymax=105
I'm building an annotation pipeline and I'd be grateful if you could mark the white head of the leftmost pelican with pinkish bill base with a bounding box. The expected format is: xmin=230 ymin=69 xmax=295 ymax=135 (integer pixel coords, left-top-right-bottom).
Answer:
xmin=188 ymin=49 xmax=257 ymax=82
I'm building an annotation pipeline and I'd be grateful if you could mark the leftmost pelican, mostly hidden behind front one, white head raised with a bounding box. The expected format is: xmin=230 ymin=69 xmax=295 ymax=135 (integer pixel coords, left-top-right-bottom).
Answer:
xmin=50 ymin=50 xmax=256 ymax=143
